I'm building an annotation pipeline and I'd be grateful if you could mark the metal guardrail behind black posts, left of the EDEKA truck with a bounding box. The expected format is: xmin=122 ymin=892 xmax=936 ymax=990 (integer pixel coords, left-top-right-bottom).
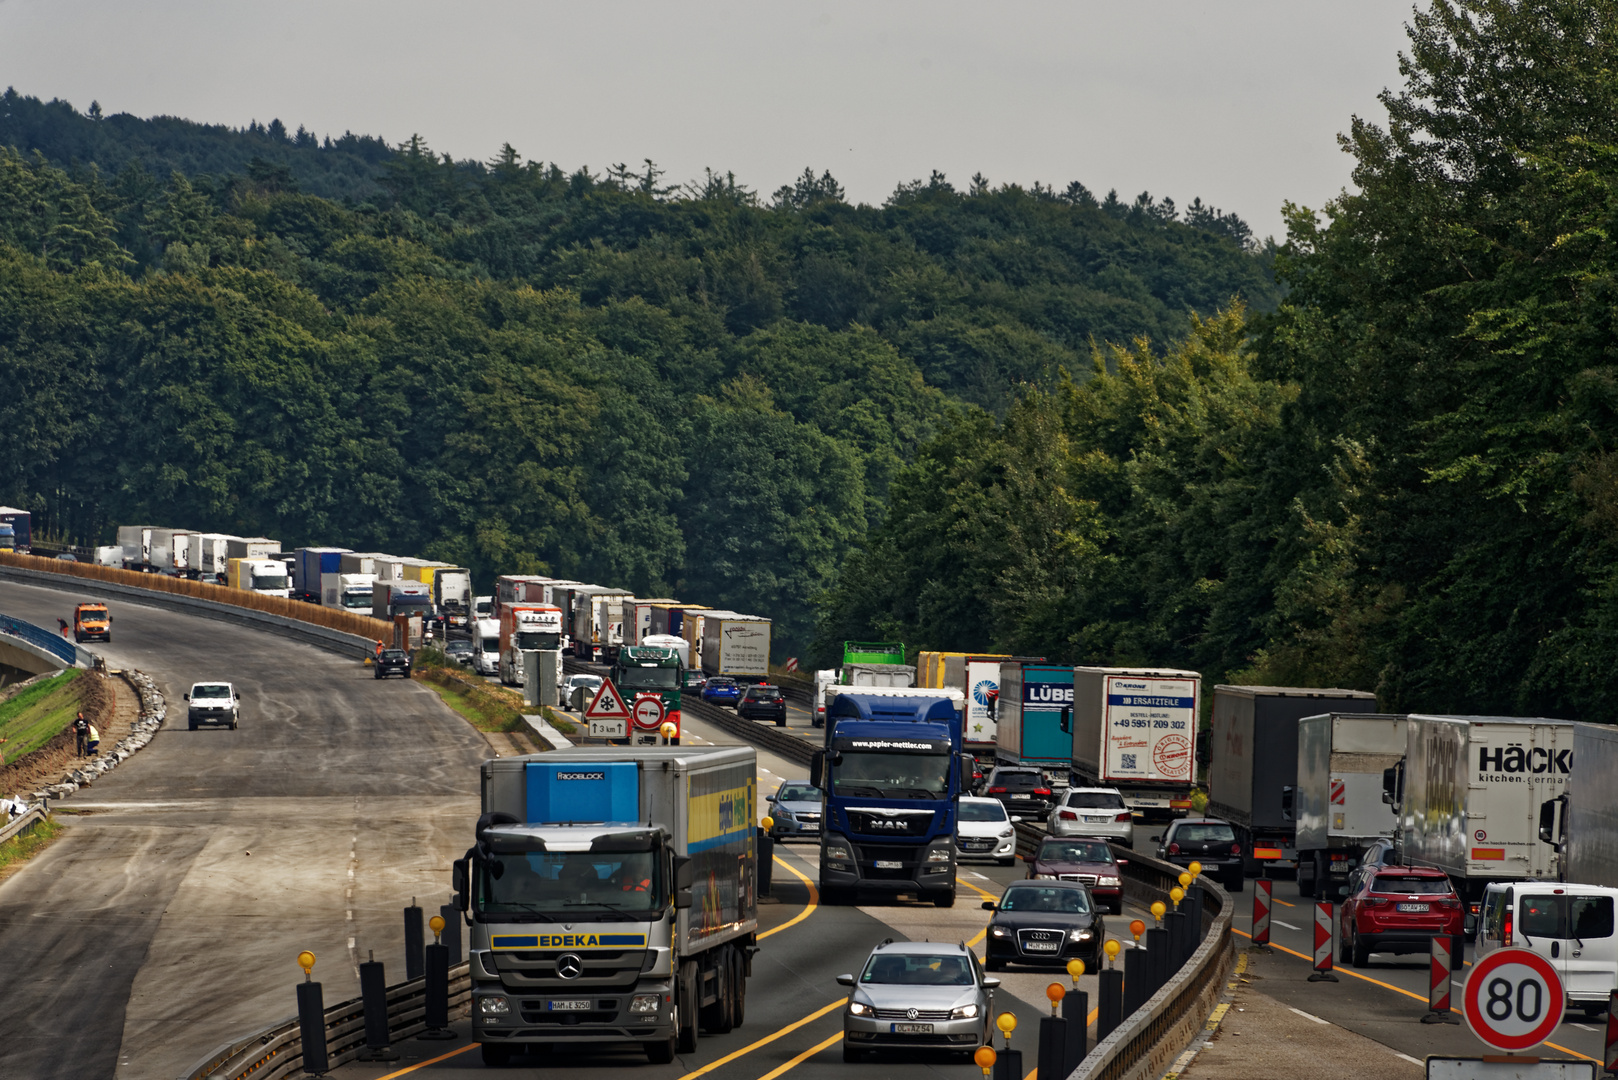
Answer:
xmin=184 ymin=960 xmax=472 ymax=1080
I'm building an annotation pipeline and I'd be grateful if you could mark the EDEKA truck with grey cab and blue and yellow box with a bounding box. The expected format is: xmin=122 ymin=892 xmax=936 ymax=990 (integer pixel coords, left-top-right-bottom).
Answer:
xmin=455 ymin=746 xmax=759 ymax=1065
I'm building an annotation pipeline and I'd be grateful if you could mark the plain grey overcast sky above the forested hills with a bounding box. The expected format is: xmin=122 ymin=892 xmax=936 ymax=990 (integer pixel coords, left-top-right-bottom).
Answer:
xmin=0 ymin=0 xmax=1411 ymax=236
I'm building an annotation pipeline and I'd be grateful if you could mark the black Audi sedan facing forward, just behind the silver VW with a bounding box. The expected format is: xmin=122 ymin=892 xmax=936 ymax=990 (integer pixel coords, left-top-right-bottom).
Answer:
xmin=984 ymin=881 xmax=1107 ymax=972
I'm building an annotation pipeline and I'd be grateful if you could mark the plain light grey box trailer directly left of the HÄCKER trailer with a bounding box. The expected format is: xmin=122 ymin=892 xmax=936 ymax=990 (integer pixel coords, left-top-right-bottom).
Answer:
xmin=1293 ymin=712 xmax=1409 ymax=904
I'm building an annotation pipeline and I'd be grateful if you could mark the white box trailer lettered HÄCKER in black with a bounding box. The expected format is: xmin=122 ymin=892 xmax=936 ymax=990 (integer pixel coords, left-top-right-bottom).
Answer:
xmin=1383 ymin=714 xmax=1576 ymax=918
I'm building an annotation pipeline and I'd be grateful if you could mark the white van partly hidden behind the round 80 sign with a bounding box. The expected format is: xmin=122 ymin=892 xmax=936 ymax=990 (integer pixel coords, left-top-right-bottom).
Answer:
xmin=1477 ymin=881 xmax=1618 ymax=1017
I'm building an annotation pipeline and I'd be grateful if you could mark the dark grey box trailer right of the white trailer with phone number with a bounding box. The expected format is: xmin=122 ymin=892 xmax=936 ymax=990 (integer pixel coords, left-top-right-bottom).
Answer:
xmin=1209 ymin=687 xmax=1380 ymax=876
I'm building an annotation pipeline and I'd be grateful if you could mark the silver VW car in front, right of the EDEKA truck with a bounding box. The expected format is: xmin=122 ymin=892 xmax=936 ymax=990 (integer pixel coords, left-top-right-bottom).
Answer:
xmin=837 ymin=941 xmax=1000 ymax=1061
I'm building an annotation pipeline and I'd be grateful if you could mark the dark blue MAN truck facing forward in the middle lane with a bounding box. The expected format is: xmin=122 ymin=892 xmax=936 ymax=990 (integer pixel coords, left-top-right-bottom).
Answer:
xmin=809 ymin=687 xmax=972 ymax=907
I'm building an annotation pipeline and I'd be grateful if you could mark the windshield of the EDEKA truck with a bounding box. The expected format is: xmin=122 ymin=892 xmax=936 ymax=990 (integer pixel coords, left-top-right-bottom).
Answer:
xmin=477 ymin=852 xmax=663 ymax=918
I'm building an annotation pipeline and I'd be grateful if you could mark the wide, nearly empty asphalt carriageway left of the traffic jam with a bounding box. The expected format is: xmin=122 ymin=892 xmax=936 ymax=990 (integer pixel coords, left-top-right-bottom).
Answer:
xmin=0 ymin=581 xmax=490 ymax=1080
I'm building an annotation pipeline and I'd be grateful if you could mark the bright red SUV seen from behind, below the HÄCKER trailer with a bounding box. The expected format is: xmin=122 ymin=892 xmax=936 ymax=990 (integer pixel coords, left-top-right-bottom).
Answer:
xmin=1336 ymin=866 xmax=1466 ymax=968
